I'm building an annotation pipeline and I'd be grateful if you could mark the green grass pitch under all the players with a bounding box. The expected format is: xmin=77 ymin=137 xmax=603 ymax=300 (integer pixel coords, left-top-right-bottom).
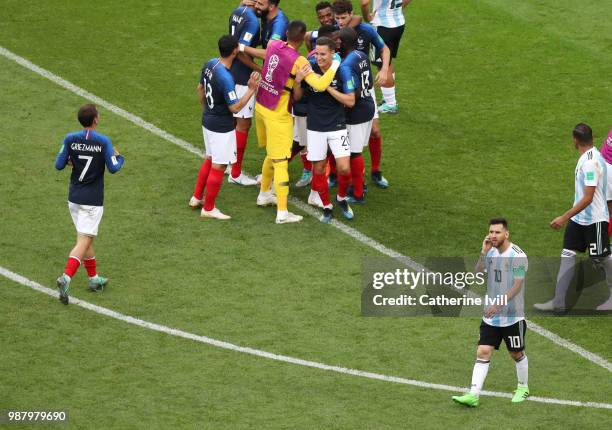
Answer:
xmin=0 ymin=0 xmax=612 ymax=429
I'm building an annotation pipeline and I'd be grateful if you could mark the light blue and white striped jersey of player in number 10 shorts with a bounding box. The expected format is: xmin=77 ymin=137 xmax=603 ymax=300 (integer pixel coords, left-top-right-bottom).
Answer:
xmin=482 ymin=243 xmax=528 ymax=327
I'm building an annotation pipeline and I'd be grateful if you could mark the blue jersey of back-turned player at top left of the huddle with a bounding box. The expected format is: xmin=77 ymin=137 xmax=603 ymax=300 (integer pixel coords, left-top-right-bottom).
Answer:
xmin=229 ymin=6 xmax=259 ymax=85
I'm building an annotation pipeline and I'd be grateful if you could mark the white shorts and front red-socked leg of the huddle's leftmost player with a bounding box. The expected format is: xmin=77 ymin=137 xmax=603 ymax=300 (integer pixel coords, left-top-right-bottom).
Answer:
xmin=200 ymin=130 xmax=236 ymax=219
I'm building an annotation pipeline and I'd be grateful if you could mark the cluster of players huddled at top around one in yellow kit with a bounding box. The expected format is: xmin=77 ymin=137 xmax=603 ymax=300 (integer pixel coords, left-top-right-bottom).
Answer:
xmin=189 ymin=0 xmax=410 ymax=224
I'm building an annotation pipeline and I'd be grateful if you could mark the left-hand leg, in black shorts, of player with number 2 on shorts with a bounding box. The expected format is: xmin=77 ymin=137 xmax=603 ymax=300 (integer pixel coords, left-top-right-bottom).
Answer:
xmin=533 ymin=220 xmax=587 ymax=312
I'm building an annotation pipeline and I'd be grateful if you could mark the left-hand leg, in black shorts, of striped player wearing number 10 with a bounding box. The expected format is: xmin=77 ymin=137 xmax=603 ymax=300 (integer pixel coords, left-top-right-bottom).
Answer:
xmin=452 ymin=321 xmax=502 ymax=407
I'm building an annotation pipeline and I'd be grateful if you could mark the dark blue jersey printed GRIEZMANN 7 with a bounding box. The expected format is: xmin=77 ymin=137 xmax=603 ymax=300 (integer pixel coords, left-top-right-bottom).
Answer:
xmin=55 ymin=130 xmax=125 ymax=206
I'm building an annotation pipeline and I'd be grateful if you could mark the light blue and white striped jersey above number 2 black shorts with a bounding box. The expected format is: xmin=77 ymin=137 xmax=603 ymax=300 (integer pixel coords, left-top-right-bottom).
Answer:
xmin=572 ymin=147 xmax=609 ymax=225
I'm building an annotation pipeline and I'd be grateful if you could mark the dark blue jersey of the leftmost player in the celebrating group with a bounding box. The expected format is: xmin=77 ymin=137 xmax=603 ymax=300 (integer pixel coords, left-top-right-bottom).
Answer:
xmin=200 ymin=58 xmax=238 ymax=133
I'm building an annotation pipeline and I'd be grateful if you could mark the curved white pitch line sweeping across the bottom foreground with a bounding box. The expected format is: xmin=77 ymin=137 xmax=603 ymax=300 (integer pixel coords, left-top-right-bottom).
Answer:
xmin=0 ymin=266 xmax=612 ymax=410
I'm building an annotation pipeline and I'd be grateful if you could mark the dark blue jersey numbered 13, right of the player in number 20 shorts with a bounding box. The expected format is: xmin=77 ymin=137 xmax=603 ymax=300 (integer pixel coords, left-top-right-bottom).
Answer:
xmin=336 ymin=50 xmax=374 ymax=124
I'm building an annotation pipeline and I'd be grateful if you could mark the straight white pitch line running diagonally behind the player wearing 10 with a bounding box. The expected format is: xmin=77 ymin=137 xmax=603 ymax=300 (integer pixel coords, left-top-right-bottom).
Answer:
xmin=0 ymin=46 xmax=612 ymax=372
